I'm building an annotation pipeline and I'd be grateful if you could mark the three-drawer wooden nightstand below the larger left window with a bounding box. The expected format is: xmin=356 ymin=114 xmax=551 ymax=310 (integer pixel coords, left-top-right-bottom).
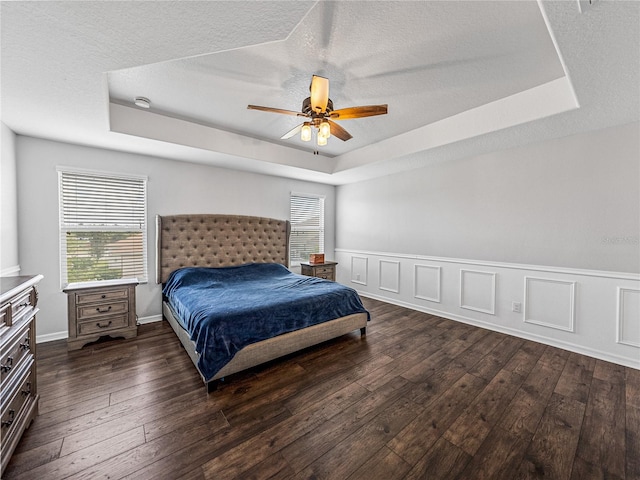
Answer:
xmin=63 ymin=278 xmax=138 ymax=350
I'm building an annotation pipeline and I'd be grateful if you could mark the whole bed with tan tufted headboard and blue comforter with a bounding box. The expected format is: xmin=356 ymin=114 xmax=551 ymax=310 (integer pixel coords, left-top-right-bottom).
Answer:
xmin=156 ymin=214 xmax=369 ymax=391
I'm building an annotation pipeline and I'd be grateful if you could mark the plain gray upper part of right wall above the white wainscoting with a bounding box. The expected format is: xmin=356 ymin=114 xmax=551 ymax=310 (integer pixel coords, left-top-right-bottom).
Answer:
xmin=336 ymin=123 xmax=640 ymax=273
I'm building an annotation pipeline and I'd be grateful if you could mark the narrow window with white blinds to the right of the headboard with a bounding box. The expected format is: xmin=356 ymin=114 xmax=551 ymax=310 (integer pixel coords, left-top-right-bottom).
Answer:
xmin=289 ymin=193 xmax=324 ymax=265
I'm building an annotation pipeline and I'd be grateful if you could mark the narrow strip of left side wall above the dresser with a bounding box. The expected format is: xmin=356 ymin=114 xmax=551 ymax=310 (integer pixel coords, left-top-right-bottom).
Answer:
xmin=0 ymin=122 xmax=20 ymax=276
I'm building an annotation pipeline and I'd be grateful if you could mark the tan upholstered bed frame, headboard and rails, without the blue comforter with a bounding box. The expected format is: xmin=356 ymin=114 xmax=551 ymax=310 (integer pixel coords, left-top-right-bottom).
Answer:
xmin=156 ymin=214 xmax=367 ymax=391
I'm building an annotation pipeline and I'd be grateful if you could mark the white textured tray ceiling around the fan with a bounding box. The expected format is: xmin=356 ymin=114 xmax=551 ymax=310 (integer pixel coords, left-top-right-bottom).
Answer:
xmin=0 ymin=0 xmax=640 ymax=184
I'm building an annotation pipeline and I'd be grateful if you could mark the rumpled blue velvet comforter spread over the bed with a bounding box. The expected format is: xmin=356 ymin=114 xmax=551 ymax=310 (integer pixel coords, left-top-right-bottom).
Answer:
xmin=163 ymin=263 xmax=368 ymax=380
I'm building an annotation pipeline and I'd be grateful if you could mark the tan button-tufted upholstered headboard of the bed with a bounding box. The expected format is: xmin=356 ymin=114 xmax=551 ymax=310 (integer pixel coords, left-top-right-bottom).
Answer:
xmin=156 ymin=214 xmax=291 ymax=283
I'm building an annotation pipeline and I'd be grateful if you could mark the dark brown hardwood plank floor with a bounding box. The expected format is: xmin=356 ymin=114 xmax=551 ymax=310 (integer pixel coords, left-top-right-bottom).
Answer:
xmin=3 ymin=299 xmax=640 ymax=480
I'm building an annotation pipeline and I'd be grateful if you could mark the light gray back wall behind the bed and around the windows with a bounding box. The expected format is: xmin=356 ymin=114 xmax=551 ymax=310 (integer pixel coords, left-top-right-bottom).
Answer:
xmin=16 ymin=136 xmax=335 ymax=341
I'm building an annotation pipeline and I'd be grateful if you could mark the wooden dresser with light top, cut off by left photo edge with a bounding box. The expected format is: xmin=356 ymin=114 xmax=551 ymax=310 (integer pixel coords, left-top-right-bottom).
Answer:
xmin=0 ymin=275 xmax=43 ymax=472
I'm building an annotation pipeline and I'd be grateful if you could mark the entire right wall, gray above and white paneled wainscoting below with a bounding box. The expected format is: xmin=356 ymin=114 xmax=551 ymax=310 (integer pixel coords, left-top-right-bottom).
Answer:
xmin=336 ymin=123 xmax=640 ymax=368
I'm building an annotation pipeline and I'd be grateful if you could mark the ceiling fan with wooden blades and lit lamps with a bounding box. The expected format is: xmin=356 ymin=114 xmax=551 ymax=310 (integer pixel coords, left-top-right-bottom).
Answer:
xmin=247 ymin=75 xmax=387 ymax=146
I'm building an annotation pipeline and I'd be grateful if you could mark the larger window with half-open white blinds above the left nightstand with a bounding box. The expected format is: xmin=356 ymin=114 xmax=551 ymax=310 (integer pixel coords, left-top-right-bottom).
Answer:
xmin=58 ymin=169 xmax=147 ymax=286
